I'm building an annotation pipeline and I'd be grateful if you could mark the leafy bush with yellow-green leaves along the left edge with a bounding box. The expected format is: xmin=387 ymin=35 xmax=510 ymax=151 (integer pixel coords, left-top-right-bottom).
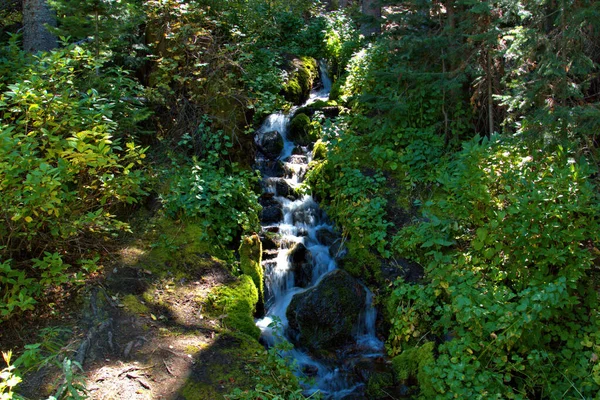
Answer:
xmin=0 ymin=41 xmax=147 ymax=318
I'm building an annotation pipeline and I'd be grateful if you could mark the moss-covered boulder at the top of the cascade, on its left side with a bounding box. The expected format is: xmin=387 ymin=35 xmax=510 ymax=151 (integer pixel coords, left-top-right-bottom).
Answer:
xmin=283 ymin=57 xmax=318 ymax=105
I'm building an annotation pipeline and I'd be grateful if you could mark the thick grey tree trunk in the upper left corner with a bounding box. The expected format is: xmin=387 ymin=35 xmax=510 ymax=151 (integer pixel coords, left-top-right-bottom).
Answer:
xmin=23 ymin=0 xmax=57 ymax=53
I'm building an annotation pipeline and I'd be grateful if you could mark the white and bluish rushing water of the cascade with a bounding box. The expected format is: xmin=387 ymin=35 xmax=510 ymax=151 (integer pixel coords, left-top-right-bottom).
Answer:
xmin=256 ymin=63 xmax=383 ymax=399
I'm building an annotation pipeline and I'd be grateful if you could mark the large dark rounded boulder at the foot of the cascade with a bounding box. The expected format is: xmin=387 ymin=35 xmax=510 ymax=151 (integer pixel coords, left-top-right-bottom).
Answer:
xmin=286 ymin=269 xmax=367 ymax=351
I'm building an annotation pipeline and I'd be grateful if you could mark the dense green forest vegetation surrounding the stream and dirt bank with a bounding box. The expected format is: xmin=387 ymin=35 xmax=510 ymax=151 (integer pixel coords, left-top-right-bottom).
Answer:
xmin=0 ymin=0 xmax=600 ymax=398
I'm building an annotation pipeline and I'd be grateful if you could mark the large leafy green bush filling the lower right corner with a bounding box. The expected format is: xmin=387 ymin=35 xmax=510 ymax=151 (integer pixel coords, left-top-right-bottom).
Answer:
xmin=389 ymin=139 xmax=600 ymax=398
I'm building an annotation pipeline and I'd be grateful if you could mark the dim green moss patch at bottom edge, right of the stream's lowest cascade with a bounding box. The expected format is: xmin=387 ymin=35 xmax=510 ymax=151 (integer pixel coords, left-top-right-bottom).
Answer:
xmin=392 ymin=342 xmax=437 ymax=398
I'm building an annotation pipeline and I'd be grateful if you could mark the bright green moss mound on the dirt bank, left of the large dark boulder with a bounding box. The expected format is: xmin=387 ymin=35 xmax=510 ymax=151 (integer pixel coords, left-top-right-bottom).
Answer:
xmin=214 ymin=275 xmax=260 ymax=339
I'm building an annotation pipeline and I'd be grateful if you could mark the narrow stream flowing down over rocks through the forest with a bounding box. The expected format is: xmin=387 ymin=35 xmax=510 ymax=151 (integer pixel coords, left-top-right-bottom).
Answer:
xmin=256 ymin=63 xmax=383 ymax=399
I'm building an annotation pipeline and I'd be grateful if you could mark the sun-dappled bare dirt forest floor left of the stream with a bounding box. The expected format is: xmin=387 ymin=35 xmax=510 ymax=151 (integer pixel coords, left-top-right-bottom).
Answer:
xmin=0 ymin=209 xmax=265 ymax=399
